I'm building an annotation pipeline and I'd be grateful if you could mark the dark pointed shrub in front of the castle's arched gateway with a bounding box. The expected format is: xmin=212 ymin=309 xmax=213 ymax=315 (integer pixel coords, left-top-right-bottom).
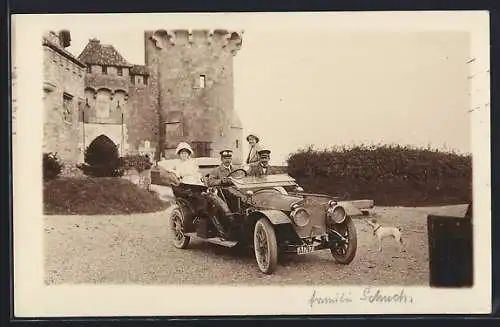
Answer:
xmin=78 ymin=135 xmax=123 ymax=177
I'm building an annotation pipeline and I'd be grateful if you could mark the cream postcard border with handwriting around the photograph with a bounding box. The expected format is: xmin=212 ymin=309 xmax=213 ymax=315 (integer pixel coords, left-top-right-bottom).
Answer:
xmin=12 ymin=11 xmax=491 ymax=317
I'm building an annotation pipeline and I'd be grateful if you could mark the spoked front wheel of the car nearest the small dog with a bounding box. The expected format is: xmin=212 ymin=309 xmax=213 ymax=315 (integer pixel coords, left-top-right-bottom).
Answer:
xmin=329 ymin=217 xmax=358 ymax=265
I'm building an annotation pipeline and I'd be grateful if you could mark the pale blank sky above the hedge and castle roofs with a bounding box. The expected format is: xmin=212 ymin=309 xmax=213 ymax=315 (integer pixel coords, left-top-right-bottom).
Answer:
xmin=68 ymin=25 xmax=471 ymax=163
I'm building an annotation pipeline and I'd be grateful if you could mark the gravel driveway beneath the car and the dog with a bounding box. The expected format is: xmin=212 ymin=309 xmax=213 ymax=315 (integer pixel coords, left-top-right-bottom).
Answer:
xmin=44 ymin=207 xmax=429 ymax=285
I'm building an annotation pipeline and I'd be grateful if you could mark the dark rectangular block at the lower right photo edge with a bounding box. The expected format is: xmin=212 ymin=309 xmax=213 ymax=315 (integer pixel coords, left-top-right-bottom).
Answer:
xmin=427 ymin=207 xmax=474 ymax=287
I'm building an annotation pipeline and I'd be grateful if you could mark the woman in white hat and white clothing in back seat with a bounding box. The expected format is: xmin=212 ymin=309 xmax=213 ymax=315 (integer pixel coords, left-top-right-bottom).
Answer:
xmin=158 ymin=142 xmax=201 ymax=184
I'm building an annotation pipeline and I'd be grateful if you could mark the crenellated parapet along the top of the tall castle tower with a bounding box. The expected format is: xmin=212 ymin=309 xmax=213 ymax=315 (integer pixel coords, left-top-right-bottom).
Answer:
xmin=146 ymin=29 xmax=243 ymax=55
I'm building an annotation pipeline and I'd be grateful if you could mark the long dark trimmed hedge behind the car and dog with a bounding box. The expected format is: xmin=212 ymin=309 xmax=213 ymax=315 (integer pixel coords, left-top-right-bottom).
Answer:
xmin=287 ymin=145 xmax=472 ymax=206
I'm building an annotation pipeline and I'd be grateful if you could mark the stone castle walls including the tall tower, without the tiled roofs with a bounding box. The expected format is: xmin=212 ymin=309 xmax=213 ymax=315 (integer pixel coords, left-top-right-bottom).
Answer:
xmin=44 ymin=30 xmax=244 ymax=164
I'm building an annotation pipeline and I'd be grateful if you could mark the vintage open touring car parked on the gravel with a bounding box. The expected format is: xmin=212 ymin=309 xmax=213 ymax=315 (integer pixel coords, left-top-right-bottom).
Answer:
xmin=164 ymin=169 xmax=363 ymax=274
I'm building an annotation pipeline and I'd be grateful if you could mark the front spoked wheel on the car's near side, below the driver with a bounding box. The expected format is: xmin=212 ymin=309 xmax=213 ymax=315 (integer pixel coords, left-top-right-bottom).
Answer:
xmin=253 ymin=218 xmax=278 ymax=274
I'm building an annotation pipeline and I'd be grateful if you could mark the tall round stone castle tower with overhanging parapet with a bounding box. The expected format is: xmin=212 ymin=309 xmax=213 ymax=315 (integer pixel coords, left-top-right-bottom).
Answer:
xmin=145 ymin=30 xmax=243 ymax=164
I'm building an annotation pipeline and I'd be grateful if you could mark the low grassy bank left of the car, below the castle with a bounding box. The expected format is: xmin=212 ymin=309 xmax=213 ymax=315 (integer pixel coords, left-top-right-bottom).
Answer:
xmin=43 ymin=177 xmax=170 ymax=215
